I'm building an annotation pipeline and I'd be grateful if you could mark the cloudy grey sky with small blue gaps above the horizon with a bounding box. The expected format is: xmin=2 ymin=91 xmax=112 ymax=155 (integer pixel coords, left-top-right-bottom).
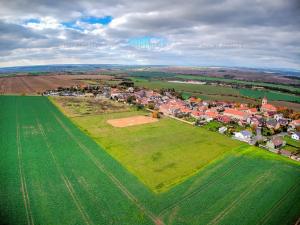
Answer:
xmin=0 ymin=0 xmax=300 ymax=69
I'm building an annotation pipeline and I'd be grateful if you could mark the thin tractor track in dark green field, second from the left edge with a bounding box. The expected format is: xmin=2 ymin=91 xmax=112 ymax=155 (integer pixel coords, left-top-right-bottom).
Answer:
xmin=36 ymin=119 xmax=93 ymax=225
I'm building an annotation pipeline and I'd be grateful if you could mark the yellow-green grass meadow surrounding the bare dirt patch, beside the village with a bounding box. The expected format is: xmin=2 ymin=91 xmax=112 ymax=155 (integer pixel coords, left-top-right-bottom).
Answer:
xmin=72 ymin=111 xmax=241 ymax=192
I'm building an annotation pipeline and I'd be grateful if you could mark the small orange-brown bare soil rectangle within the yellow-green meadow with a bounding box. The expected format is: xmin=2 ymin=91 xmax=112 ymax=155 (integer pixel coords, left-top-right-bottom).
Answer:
xmin=107 ymin=116 xmax=158 ymax=127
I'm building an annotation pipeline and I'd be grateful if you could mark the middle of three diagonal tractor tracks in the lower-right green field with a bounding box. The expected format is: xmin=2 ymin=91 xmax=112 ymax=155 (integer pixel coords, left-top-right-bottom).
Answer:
xmin=208 ymin=171 xmax=271 ymax=225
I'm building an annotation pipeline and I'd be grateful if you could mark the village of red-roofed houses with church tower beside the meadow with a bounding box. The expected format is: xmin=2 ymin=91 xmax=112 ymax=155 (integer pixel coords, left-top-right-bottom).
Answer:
xmin=43 ymin=82 xmax=300 ymax=161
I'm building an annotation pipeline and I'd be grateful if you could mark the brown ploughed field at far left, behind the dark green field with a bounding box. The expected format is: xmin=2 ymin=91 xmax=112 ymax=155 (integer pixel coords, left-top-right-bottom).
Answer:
xmin=0 ymin=74 xmax=111 ymax=94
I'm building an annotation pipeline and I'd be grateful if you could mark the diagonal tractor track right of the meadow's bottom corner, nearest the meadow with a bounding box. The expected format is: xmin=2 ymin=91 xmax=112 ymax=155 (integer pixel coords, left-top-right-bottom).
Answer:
xmin=159 ymin=156 xmax=243 ymax=216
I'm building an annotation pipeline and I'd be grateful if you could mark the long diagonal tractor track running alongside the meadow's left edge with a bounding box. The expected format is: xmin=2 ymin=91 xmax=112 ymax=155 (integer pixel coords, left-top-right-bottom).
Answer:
xmin=52 ymin=112 xmax=165 ymax=225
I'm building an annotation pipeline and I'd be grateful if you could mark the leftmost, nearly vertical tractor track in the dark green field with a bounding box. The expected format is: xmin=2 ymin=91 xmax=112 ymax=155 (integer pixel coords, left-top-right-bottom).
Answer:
xmin=16 ymin=106 xmax=34 ymax=225
